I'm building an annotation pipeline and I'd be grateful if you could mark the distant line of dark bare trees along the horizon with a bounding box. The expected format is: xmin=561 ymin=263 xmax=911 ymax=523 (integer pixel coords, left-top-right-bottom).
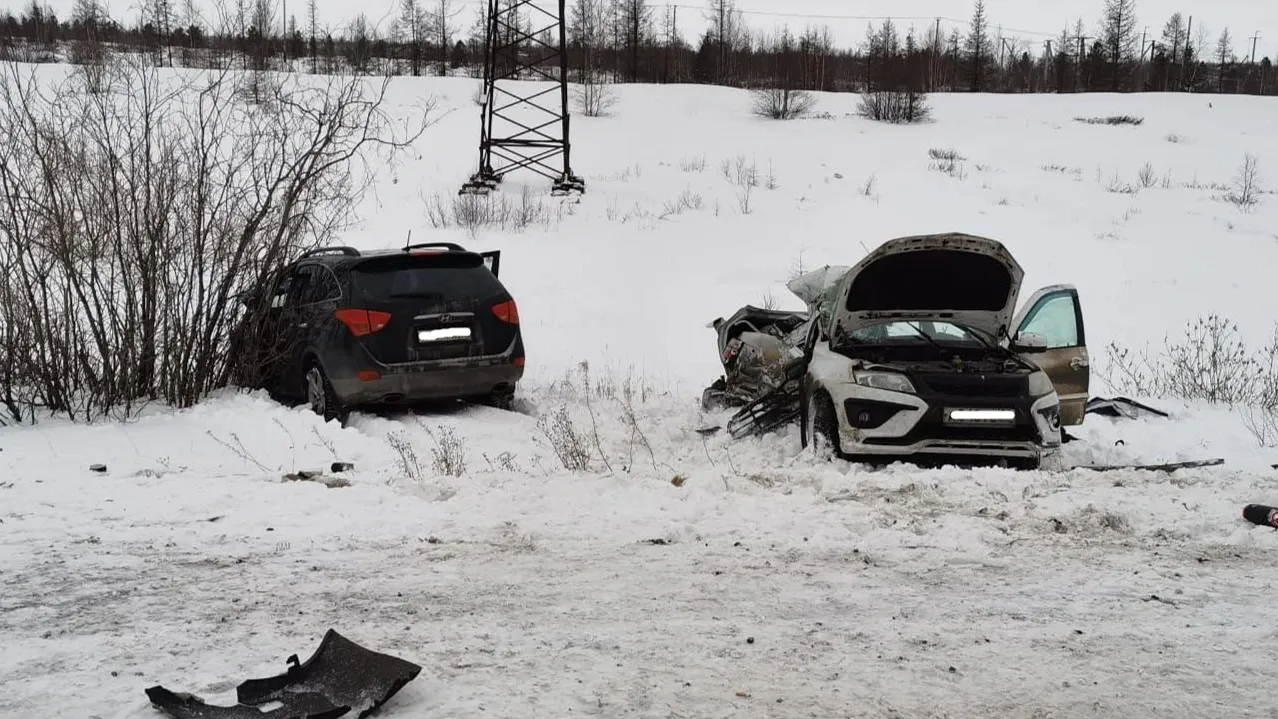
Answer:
xmin=0 ymin=0 xmax=1278 ymax=95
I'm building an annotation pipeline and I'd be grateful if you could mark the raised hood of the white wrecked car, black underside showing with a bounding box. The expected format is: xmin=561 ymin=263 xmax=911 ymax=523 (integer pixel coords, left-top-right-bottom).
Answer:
xmin=827 ymin=232 xmax=1025 ymax=338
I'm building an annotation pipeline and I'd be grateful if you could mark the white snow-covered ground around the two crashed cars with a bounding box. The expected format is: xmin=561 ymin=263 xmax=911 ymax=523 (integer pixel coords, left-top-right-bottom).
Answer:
xmin=0 ymin=64 xmax=1278 ymax=719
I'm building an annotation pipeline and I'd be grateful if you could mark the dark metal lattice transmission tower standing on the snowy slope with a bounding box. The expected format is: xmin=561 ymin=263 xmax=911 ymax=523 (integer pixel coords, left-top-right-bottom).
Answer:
xmin=460 ymin=0 xmax=585 ymax=195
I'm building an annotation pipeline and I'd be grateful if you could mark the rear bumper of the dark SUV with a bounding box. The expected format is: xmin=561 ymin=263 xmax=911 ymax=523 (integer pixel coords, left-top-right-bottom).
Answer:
xmin=330 ymin=337 xmax=524 ymax=407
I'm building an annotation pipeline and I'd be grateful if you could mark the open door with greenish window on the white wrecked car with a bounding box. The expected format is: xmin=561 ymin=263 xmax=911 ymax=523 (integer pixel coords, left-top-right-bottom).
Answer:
xmin=1012 ymin=285 xmax=1091 ymax=427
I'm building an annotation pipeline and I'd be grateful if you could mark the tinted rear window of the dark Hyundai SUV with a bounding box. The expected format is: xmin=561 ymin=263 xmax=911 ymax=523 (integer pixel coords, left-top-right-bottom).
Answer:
xmin=350 ymin=253 xmax=506 ymax=301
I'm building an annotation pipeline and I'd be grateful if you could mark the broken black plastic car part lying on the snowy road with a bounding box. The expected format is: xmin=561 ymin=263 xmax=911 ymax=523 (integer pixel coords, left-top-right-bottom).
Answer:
xmin=146 ymin=630 xmax=422 ymax=719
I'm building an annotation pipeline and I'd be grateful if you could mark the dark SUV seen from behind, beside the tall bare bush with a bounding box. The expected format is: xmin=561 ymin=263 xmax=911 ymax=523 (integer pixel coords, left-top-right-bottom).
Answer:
xmin=238 ymin=243 xmax=524 ymax=421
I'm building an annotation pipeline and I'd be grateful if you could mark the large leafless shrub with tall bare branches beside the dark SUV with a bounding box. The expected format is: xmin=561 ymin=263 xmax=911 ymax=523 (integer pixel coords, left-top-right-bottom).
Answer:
xmin=0 ymin=57 xmax=428 ymax=419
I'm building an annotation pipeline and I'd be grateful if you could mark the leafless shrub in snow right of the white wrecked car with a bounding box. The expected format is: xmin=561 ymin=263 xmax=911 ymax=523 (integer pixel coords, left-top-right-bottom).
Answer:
xmin=1102 ymin=314 xmax=1278 ymax=406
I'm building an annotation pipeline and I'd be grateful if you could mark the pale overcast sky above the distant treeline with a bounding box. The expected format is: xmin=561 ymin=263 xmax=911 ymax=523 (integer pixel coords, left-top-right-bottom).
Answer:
xmin=12 ymin=0 xmax=1278 ymax=57
